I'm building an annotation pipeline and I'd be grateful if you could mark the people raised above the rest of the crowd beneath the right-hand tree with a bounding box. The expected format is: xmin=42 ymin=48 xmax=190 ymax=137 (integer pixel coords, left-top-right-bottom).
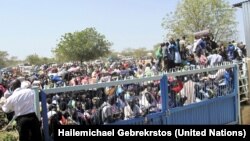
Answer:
xmin=156 ymin=36 xmax=246 ymax=71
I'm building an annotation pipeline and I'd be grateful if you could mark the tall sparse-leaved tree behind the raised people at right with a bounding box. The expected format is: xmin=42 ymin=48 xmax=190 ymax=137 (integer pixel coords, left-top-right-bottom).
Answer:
xmin=162 ymin=0 xmax=237 ymax=41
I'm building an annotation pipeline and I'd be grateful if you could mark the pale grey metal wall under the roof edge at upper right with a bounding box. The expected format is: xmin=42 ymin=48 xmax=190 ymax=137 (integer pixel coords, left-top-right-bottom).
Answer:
xmin=242 ymin=1 xmax=250 ymax=57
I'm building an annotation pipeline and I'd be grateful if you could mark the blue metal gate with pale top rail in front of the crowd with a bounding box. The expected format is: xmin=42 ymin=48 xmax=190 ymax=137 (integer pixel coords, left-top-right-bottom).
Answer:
xmin=38 ymin=64 xmax=239 ymax=141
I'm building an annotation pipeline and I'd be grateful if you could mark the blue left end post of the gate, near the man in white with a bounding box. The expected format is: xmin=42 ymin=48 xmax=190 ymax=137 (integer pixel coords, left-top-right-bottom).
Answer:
xmin=41 ymin=91 xmax=50 ymax=141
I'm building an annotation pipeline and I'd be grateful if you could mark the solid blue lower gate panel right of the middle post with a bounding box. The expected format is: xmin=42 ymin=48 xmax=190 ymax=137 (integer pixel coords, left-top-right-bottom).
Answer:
xmin=167 ymin=95 xmax=237 ymax=125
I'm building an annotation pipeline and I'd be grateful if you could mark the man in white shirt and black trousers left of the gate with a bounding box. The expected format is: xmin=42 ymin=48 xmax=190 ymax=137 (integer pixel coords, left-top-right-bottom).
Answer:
xmin=2 ymin=79 xmax=42 ymax=141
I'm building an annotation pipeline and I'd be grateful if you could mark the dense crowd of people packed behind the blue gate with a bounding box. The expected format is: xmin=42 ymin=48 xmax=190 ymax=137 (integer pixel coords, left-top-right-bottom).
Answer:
xmin=0 ymin=33 xmax=246 ymax=139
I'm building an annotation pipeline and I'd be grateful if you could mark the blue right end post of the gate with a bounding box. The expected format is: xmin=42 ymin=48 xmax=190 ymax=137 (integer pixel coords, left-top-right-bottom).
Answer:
xmin=233 ymin=64 xmax=241 ymax=124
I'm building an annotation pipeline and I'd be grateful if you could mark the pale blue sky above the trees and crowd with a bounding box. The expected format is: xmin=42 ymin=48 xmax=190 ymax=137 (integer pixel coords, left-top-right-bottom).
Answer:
xmin=0 ymin=0 xmax=245 ymax=59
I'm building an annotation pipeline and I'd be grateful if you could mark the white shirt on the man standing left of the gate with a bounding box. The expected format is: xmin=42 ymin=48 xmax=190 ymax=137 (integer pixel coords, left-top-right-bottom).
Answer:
xmin=2 ymin=88 xmax=35 ymax=117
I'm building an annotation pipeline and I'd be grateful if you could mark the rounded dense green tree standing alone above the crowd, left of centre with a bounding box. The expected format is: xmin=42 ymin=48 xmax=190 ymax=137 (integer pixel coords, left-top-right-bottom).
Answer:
xmin=53 ymin=28 xmax=112 ymax=63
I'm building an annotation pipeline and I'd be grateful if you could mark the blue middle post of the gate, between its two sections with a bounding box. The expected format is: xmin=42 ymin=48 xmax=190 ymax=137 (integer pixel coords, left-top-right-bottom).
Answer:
xmin=160 ymin=75 xmax=168 ymax=124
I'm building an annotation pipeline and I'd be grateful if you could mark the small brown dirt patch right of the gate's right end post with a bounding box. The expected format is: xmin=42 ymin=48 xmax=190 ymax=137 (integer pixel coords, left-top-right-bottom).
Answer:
xmin=241 ymin=102 xmax=250 ymax=125
